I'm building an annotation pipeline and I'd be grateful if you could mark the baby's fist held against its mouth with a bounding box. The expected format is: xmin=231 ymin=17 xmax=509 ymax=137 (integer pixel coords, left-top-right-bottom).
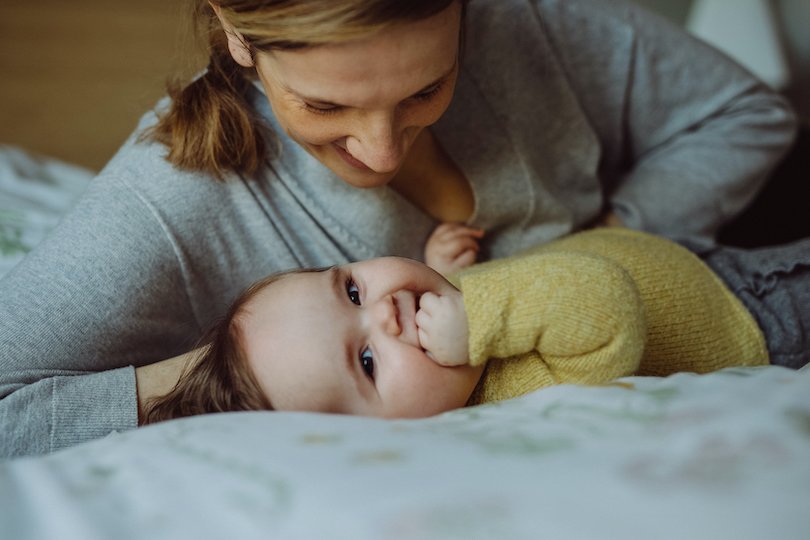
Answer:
xmin=416 ymin=291 xmax=469 ymax=367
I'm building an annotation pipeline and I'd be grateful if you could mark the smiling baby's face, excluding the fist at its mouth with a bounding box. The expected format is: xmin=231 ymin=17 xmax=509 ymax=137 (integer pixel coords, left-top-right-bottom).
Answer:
xmin=242 ymin=257 xmax=483 ymax=418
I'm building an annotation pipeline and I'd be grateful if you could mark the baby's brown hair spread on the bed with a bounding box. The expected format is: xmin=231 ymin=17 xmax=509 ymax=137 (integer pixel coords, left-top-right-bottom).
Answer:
xmin=141 ymin=268 xmax=324 ymax=424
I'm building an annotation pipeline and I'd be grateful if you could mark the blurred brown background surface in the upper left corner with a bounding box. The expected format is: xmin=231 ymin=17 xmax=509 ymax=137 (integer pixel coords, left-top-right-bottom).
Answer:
xmin=0 ymin=0 xmax=204 ymax=171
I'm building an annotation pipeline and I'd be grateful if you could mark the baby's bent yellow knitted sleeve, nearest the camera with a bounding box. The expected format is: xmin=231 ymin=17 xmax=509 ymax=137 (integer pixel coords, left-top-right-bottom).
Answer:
xmin=460 ymin=252 xmax=646 ymax=402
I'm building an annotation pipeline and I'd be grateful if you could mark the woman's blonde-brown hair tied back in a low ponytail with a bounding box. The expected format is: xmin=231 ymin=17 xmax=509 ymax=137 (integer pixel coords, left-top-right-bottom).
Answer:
xmin=145 ymin=0 xmax=468 ymax=180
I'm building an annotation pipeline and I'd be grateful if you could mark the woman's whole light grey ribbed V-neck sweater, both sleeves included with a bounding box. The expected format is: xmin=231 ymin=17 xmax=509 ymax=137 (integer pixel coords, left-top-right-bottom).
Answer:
xmin=0 ymin=0 xmax=794 ymax=457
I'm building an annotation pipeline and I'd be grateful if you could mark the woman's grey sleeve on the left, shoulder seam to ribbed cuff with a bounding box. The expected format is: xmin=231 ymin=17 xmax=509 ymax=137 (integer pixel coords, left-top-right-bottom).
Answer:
xmin=0 ymin=175 xmax=198 ymax=458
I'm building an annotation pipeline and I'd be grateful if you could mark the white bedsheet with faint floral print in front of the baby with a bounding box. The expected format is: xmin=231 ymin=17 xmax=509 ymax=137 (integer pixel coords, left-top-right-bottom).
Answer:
xmin=0 ymin=367 xmax=810 ymax=540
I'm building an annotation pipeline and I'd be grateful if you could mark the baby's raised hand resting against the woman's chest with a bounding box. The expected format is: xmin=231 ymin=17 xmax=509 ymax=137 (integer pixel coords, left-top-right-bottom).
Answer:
xmin=425 ymin=223 xmax=484 ymax=276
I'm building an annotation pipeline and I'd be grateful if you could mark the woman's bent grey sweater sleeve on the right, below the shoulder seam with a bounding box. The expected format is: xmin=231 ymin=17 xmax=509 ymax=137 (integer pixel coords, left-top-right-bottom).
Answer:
xmin=537 ymin=0 xmax=795 ymax=237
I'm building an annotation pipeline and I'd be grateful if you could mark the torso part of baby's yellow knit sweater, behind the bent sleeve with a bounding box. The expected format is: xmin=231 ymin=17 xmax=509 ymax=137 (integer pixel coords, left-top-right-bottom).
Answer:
xmin=526 ymin=228 xmax=769 ymax=377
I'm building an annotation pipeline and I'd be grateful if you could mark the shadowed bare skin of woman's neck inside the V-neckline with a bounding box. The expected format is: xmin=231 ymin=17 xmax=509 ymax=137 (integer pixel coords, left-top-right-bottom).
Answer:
xmin=388 ymin=129 xmax=475 ymax=222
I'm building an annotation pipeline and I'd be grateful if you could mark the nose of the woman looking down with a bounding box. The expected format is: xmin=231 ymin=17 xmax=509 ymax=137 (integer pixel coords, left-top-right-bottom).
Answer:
xmin=346 ymin=112 xmax=405 ymax=173
